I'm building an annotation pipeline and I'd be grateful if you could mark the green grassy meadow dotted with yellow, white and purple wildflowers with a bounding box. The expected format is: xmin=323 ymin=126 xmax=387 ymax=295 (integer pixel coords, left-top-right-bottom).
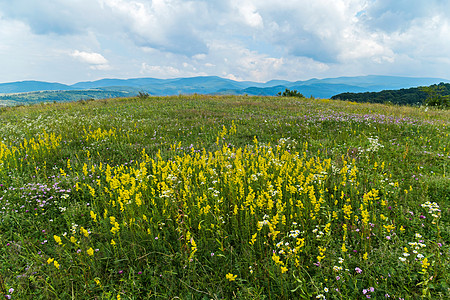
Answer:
xmin=0 ymin=95 xmax=450 ymax=299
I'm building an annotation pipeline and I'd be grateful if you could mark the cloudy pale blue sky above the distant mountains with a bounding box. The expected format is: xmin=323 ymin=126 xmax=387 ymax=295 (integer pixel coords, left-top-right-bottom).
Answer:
xmin=0 ymin=0 xmax=450 ymax=84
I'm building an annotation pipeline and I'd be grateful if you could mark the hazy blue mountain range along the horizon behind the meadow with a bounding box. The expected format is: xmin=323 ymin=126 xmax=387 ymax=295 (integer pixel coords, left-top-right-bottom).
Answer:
xmin=0 ymin=75 xmax=450 ymax=104
